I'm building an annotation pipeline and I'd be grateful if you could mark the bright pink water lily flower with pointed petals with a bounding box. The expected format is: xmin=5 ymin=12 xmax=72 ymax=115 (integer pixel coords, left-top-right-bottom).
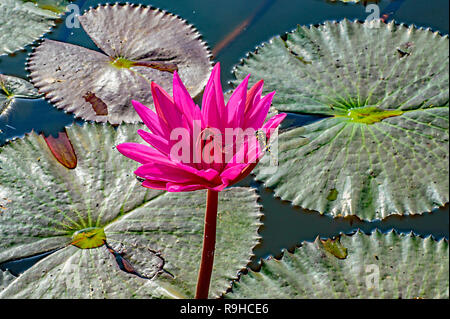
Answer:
xmin=117 ymin=63 xmax=286 ymax=192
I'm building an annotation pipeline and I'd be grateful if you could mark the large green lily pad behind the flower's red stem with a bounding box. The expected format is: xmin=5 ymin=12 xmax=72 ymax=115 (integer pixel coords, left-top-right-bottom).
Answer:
xmin=0 ymin=124 xmax=261 ymax=298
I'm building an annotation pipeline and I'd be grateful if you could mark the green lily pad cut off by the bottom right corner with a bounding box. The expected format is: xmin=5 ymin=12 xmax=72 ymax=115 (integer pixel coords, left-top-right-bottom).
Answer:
xmin=225 ymin=231 xmax=449 ymax=299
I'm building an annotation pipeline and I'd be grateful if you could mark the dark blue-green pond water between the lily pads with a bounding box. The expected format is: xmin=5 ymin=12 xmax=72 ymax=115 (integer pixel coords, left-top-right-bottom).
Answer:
xmin=0 ymin=0 xmax=449 ymax=273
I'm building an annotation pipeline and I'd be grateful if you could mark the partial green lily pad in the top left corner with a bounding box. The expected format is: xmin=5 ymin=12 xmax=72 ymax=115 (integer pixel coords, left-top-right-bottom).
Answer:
xmin=0 ymin=0 xmax=69 ymax=56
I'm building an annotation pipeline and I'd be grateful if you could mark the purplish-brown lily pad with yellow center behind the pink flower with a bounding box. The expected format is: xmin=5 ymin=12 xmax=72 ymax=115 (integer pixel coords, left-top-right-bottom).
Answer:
xmin=29 ymin=4 xmax=211 ymax=124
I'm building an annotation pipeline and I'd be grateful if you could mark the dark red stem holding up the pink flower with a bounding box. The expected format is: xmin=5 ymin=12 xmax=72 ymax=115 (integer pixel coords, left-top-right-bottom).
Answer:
xmin=195 ymin=190 xmax=219 ymax=299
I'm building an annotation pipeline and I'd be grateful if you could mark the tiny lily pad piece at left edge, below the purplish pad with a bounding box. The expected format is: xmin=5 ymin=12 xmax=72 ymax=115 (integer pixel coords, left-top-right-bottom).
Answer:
xmin=0 ymin=74 xmax=40 ymax=116
